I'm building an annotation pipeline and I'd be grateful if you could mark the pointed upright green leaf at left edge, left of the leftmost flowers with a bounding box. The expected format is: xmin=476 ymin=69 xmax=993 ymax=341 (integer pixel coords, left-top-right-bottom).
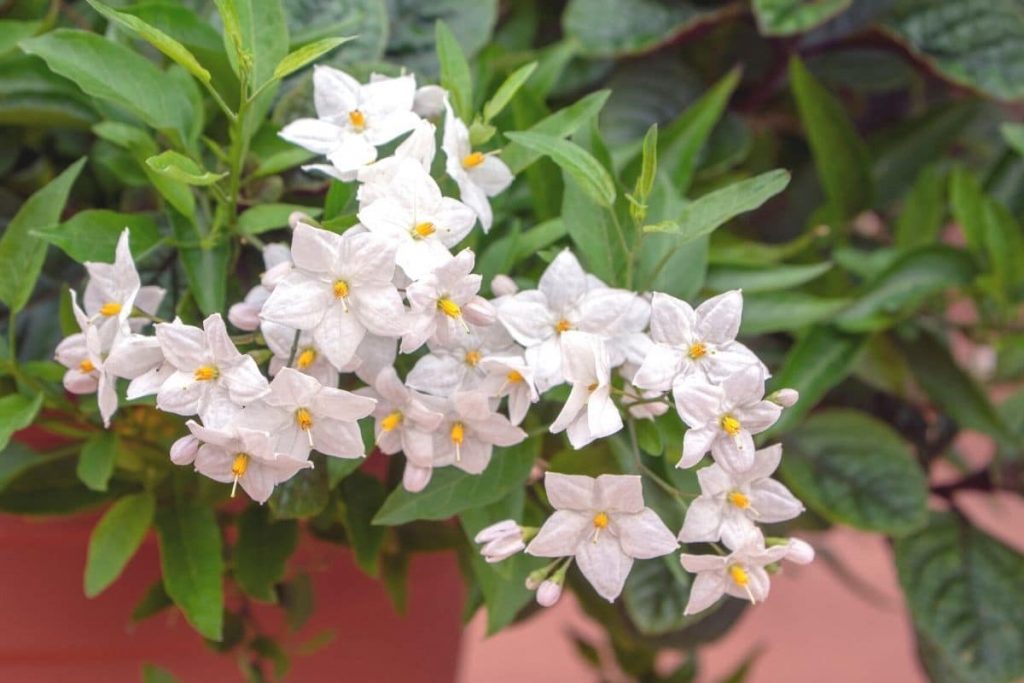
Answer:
xmin=0 ymin=159 xmax=85 ymax=312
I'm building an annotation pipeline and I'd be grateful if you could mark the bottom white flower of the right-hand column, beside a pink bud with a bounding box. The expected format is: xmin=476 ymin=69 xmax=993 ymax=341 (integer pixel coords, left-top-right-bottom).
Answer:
xmin=679 ymin=529 xmax=788 ymax=614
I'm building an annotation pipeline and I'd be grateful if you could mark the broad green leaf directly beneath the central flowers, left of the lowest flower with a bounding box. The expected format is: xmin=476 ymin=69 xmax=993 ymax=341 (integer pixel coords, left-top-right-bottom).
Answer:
xmin=374 ymin=438 xmax=541 ymax=526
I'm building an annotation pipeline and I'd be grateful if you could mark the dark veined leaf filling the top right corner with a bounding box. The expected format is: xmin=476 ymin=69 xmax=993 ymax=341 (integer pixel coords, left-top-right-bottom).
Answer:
xmin=883 ymin=0 xmax=1024 ymax=99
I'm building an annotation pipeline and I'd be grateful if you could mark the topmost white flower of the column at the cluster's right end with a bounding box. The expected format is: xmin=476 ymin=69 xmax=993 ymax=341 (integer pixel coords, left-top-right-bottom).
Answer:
xmin=633 ymin=290 xmax=767 ymax=391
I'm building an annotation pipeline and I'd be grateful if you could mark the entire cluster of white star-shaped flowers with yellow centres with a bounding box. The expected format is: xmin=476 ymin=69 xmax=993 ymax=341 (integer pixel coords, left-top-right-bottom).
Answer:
xmin=56 ymin=67 xmax=812 ymax=612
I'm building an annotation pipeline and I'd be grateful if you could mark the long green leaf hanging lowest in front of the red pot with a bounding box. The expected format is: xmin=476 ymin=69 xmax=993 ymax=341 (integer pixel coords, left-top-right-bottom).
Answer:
xmin=156 ymin=500 xmax=224 ymax=640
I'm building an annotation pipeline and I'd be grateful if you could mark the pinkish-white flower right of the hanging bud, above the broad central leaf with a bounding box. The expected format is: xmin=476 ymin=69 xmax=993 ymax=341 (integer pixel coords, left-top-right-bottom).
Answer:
xmin=433 ymin=391 xmax=526 ymax=474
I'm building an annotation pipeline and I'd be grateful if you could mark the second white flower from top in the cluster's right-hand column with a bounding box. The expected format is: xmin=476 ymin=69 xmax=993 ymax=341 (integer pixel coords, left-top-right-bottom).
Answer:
xmin=673 ymin=364 xmax=782 ymax=472
